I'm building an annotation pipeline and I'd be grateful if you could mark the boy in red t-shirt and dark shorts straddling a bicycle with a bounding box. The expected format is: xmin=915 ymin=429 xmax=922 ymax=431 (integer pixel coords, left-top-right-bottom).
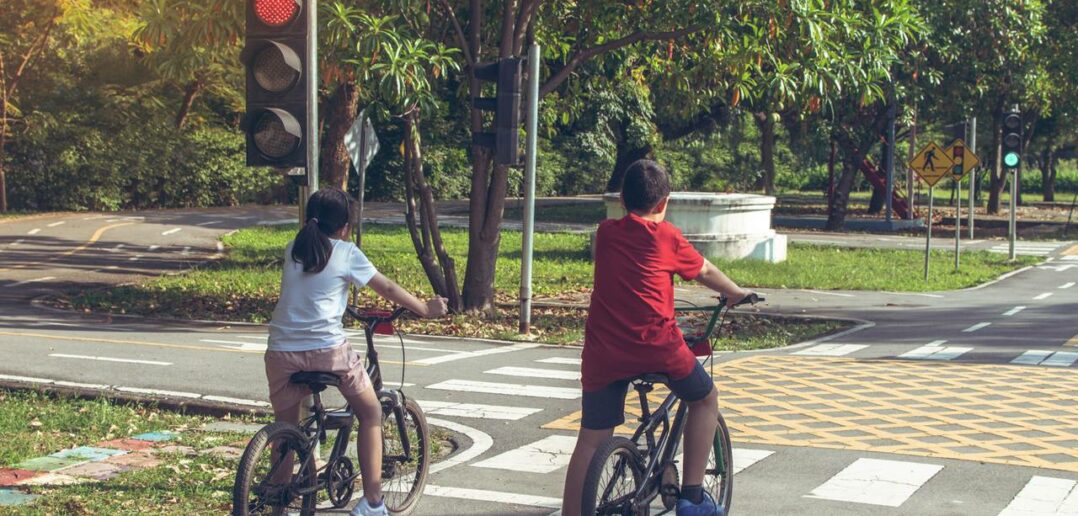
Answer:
xmin=562 ymin=159 xmax=750 ymax=516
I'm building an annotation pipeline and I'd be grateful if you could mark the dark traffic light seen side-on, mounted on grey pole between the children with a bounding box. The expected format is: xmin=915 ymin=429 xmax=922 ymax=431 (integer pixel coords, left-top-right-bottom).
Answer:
xmin=472 ymin=57 xmax=521 ymax=166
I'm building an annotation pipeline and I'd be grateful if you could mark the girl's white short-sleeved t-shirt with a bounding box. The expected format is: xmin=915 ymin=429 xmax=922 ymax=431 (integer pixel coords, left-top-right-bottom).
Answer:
xmin=267 ymin=239 xmax=377 ymax=351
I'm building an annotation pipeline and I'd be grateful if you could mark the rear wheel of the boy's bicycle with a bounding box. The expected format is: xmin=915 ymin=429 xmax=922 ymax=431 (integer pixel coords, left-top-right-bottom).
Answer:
xmin=580 ymin=437 xmax=648 ymax=516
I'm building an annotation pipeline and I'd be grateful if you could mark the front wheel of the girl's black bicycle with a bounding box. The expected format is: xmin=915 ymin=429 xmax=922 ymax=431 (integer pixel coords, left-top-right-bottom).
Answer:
xmin=382 ymin=399 xmax=430 ymax=516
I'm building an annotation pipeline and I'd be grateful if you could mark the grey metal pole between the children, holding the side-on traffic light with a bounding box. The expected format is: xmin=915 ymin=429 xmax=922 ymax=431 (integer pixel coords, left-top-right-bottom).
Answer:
xmin=520 ymin=43 xmax=539 ymax=335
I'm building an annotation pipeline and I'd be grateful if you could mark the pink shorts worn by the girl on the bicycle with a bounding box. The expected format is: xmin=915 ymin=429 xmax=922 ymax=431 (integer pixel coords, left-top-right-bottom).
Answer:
xmin=265 ymin=343 xmax=371 ymax=412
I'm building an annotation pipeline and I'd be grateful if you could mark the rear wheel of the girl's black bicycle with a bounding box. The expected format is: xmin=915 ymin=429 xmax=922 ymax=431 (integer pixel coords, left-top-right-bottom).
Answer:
xmin=232 ymin=421 xmax=318 ymax=516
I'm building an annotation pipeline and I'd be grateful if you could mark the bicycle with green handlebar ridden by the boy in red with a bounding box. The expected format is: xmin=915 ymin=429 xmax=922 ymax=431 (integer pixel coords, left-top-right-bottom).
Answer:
xmin=581 ymin=293 xmax=764 ymax=516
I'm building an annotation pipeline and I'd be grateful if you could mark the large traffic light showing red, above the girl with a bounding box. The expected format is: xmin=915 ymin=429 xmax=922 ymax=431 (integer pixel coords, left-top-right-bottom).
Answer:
xmin=240 ymin=0 xmax=313 ymax=168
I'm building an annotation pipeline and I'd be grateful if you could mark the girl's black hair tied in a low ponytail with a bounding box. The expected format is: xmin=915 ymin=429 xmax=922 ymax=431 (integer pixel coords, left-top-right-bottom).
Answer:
xmin=292 ymin=189 xmax=351 ymax=273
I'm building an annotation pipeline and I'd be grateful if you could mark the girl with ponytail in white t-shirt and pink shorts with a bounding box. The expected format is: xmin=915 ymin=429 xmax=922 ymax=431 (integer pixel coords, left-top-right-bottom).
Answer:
xmin=265 ymin=189 xmax=446 ymax=516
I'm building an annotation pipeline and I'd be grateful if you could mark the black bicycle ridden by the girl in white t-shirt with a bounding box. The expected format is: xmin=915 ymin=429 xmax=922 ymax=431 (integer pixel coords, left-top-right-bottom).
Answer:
xmin=232 ymin=306 xmax=430 ymax=516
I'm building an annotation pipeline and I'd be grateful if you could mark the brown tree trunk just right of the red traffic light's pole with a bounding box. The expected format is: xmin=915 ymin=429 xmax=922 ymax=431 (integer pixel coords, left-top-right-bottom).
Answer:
xmin=318 ymin=82 xmax=360 ymax=191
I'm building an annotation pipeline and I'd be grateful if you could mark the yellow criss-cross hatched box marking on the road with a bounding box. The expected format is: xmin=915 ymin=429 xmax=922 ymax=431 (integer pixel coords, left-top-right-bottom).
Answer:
xmin=544 ymin=355 xmax=1078 ymax=472
